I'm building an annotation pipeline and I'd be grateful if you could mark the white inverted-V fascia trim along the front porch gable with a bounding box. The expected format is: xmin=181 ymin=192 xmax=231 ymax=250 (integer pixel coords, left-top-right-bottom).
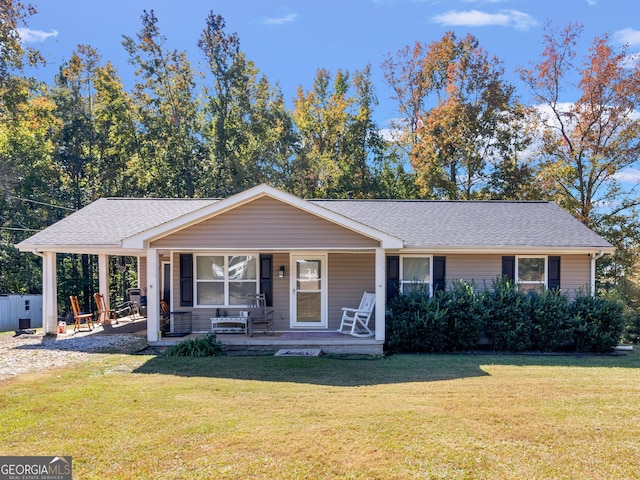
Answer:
xmin=122 ymin=184 xmax=403 ymax=249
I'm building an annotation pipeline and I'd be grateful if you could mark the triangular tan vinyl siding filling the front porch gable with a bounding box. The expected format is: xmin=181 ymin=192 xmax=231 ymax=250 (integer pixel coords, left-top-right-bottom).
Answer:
xmin=151 ymin=197 xmax=378 ymax=250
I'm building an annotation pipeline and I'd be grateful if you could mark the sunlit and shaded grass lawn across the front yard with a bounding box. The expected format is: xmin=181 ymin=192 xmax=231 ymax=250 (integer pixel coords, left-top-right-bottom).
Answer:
xmin=0 ymin=351 xmax=640 ymax=479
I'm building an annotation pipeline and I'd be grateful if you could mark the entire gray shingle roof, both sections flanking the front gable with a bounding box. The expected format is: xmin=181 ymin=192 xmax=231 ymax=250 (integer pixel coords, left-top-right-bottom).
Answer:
xmin=19 ymin=193 xmax=611 ymax=249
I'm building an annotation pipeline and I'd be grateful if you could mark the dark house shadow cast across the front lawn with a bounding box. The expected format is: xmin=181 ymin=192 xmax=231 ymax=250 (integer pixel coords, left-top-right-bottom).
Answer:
xmin=134 ymin=346 xmax=640 ymax=387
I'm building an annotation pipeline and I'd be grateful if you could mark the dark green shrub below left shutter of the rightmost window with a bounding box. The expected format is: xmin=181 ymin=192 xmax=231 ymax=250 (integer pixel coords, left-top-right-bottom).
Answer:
xmin=483 ymin=278 xmax=533 ymax=352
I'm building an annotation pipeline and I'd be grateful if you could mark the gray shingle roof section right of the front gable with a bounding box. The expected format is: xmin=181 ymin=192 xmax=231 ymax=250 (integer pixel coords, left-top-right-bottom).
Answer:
xmin=313 ymin=200 xmax=611 ymax=248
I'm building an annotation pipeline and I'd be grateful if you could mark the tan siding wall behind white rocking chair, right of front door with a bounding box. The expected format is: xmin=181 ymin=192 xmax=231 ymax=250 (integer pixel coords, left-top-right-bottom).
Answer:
xmin=328 ymin=253 xmax=375 ymax=330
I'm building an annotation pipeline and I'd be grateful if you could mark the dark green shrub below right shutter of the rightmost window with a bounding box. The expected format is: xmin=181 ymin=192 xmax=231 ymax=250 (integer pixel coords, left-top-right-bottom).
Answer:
xmin=527 ymin=290 xmax=573 ymax=352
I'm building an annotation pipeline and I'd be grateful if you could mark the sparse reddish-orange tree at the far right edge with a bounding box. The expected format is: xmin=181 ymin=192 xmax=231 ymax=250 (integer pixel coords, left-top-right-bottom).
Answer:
xmin=520 ymin=24 xmax=640 ymax=284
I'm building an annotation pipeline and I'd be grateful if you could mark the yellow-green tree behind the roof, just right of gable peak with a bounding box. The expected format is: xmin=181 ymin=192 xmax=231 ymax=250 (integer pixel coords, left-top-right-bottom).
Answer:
xmin=293 ymin=65 xmax=400 ymax=198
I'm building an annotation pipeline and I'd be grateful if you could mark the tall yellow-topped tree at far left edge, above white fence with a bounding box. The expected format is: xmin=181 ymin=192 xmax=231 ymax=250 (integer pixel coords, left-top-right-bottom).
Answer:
xmin=0 ymin=0 xmax=61 ymax=293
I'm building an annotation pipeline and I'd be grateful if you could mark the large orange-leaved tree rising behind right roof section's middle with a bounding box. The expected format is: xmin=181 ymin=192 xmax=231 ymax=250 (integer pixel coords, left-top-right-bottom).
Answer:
xmin=385 ymin=32 xmax=525 ymax=199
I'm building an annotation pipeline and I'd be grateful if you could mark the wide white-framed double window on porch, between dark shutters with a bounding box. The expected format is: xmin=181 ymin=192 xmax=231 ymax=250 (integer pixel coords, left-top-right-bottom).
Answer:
xmin=194 ymin=253 xmax=258 ymax=307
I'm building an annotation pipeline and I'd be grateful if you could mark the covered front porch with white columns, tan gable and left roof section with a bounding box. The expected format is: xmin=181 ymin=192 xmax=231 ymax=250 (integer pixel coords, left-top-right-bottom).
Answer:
xmin=19 ymin=186 xmax=403 ymax=353
